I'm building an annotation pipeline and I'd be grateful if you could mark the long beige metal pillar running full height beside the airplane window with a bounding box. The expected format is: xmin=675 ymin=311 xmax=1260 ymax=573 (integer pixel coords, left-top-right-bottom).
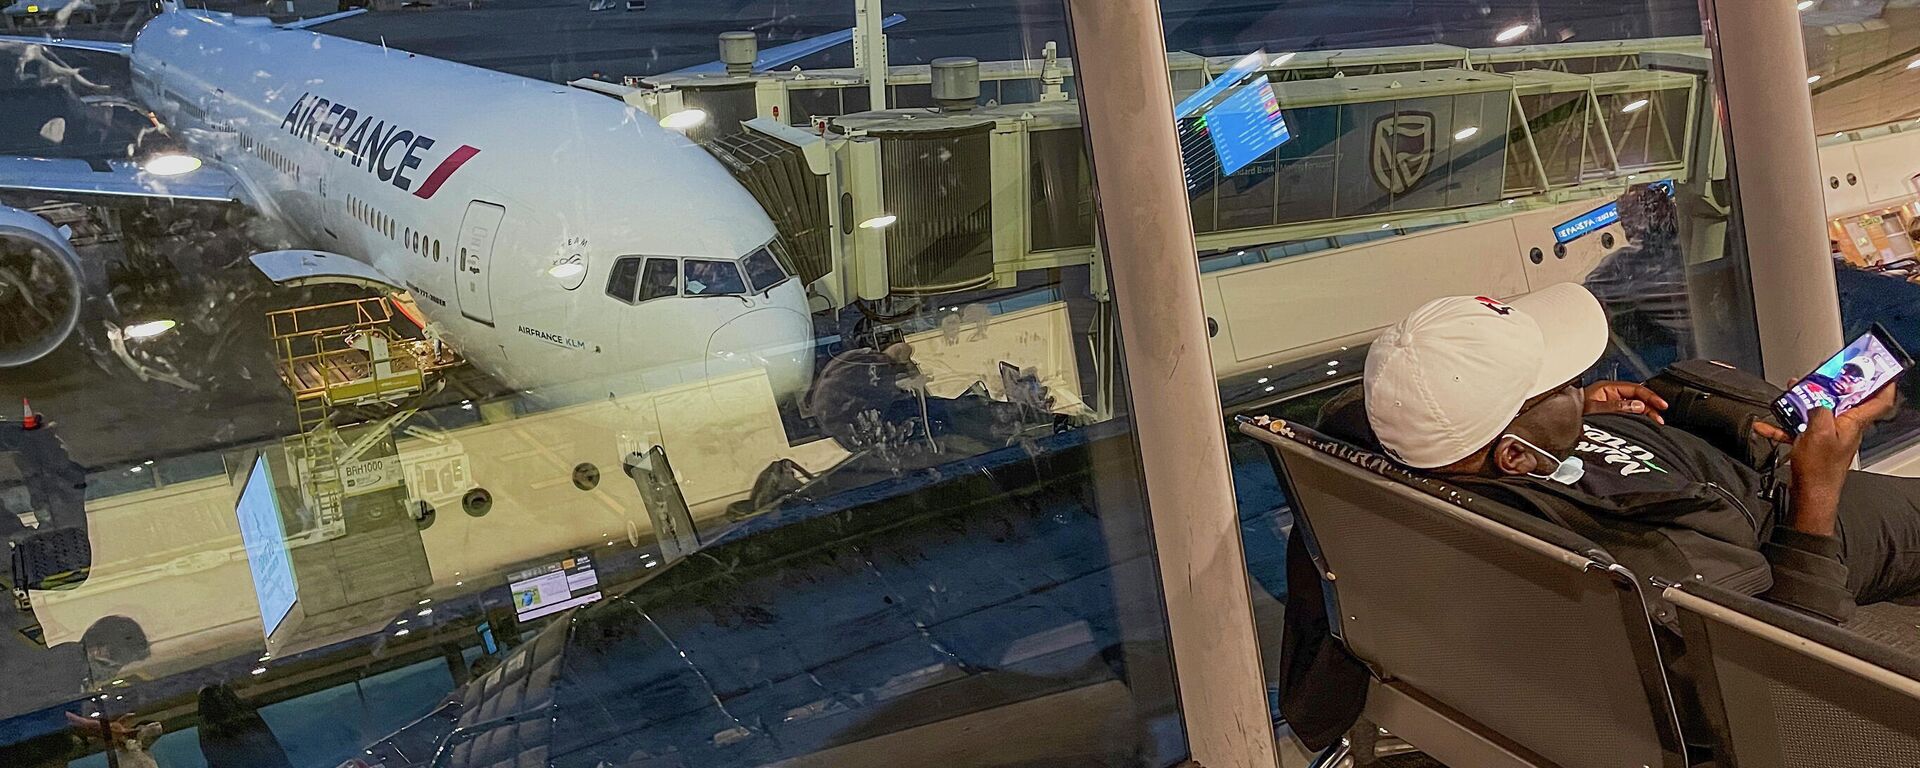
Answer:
xmin=1068 ymin=0 xmax=1275 ymax=768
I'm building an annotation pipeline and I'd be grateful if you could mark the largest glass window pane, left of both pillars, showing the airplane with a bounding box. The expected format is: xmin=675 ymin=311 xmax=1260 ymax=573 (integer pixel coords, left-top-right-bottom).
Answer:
xmin=0 ymin=0 xmax=1188 ymax=768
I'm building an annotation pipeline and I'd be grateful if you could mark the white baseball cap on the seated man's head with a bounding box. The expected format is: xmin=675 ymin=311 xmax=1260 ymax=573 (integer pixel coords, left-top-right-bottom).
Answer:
xmin=1363 ymin=282 xmax=1607 ymax=468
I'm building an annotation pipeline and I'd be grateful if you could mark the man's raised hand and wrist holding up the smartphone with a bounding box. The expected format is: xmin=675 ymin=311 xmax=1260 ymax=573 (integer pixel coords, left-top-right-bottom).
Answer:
xmin=1753 ymin=384 xmax=1899 ymax=536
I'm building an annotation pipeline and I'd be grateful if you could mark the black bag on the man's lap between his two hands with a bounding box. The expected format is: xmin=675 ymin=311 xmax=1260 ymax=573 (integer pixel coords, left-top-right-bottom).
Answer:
xmin=1647 ymin=359 xmax=1786 ymax=472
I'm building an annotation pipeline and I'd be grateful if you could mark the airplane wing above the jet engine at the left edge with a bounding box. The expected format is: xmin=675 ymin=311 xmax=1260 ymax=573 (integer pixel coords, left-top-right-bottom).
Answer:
xmin=0 ymin=157 xmax=240 ymax=202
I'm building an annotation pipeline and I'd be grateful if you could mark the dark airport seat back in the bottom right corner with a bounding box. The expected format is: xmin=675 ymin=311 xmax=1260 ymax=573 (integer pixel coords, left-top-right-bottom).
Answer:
xmin=1665 ymin=584 xmax=1920 ymax=768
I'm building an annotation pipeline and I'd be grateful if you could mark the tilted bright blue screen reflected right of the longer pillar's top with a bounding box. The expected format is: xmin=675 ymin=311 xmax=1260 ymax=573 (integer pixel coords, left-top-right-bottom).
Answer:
xmin=1179 ymin=77 xmax=1294 ymax=192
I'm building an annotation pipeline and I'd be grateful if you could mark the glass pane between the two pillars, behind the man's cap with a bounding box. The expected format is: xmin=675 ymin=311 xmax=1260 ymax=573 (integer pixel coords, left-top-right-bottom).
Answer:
xmin=1162 ymin=2 xmax=1759 ymax=753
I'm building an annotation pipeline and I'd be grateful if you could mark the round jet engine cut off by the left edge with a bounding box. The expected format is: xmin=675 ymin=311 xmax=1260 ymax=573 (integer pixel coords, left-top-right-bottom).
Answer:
xmin=0 ymin=205 xmax=83 ymax=369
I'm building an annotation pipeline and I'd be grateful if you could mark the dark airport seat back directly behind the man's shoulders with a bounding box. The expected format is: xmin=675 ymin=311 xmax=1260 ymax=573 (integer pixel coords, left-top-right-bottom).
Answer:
xmin=1240 ymin=420 xmax=1686 ymax=768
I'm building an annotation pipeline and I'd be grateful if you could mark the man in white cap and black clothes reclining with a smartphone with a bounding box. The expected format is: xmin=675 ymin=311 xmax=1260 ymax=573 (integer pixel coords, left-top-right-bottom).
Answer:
xmin=1363 ymin=284 xmax=1920 ymax=622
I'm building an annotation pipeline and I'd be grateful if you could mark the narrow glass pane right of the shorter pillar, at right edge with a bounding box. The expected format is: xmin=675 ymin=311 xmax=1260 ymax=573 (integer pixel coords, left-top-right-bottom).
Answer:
xmin=1801 ymin=2 xmax=1920 ymax=458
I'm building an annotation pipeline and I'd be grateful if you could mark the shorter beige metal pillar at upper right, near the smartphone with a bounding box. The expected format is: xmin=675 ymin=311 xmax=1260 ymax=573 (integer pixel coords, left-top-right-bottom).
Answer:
xmin=1701 ymin=0 xmax=1843 ymax=382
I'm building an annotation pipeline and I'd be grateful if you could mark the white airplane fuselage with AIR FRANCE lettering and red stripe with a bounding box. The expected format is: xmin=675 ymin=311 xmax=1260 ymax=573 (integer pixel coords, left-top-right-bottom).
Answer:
xmin=132 ymin=12 xmax=812 ymax=401
